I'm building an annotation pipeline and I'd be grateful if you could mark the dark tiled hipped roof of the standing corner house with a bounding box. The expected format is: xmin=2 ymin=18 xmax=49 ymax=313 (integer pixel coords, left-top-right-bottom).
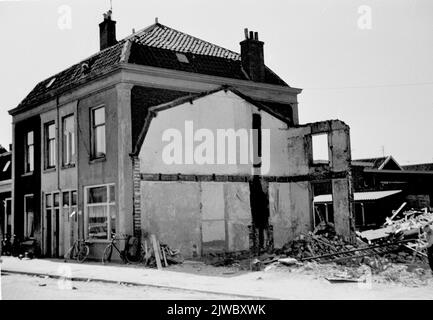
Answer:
xmin=9 ymin=23 xmax=288 ymax=114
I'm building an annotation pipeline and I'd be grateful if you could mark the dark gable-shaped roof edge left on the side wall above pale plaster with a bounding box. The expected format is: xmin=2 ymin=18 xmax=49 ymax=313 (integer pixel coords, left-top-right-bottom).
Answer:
xmin=132 ymin=86 xmax=292 ymax=155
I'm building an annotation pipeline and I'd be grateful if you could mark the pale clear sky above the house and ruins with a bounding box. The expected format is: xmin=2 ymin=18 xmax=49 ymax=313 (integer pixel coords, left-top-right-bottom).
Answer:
xmin=0 ymin=0 xmax=433 ymax=164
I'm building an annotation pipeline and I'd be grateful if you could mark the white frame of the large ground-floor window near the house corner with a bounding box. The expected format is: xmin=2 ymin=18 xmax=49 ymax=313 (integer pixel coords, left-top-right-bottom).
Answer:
xmin=83 ymin=183 xmax=118 ymax=243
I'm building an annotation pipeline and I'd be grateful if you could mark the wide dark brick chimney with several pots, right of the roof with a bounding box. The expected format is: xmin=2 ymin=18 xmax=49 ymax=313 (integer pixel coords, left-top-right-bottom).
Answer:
xmin=240 ymin=29 xmax=265 ymax=82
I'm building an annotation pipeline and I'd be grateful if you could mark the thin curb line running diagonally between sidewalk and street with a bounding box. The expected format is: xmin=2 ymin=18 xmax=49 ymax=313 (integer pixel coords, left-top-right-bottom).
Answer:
xmin=1 ymin=268 xmax=275 ymax=300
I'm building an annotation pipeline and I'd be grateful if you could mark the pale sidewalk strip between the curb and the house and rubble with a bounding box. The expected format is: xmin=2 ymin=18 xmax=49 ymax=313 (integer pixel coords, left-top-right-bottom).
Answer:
xmin=1 ymin=257 xmax=433 ymax=299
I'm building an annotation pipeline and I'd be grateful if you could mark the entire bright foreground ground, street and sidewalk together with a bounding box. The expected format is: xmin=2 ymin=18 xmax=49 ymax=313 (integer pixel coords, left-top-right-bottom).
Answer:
xmin=1 ymin=257 xmax=433 ymax=300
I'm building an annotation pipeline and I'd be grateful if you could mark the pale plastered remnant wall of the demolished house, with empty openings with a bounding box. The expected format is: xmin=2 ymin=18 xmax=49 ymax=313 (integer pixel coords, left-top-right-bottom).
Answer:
xmin=134 ymin=92 xmax=352 ymax=257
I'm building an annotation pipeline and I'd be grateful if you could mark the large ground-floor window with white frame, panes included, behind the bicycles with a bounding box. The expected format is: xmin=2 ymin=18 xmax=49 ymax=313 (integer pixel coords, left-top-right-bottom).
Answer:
xmin=85 ymin=185 xmax=116 ymax=240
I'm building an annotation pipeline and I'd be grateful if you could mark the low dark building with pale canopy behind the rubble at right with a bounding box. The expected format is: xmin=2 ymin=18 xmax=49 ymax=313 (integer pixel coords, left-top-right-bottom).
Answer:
xmin=314 ymin=156 xmax=433 ymax=230
